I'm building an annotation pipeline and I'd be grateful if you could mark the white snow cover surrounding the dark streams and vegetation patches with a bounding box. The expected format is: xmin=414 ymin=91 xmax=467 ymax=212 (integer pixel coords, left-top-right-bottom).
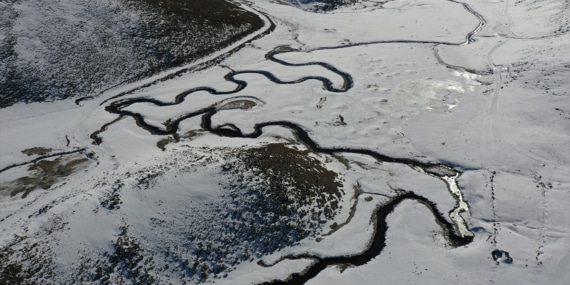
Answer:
xmin=0 ymin=0 xmax=570 ymax=284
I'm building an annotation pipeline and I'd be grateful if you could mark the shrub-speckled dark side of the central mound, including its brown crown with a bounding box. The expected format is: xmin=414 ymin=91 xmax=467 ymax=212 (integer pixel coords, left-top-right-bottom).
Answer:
xmin=144 ymin=143 xmax=344 ymax=282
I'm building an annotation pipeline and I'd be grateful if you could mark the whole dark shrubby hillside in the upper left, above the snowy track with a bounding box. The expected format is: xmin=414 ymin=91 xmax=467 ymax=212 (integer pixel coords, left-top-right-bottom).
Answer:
xmin=0 ymin=0 xmax=263 ymax=108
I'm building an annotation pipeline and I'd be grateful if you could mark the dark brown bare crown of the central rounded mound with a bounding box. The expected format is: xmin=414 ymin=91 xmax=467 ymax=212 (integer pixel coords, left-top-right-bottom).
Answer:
xmin=225 ymin=143 xmax=342 ymax=219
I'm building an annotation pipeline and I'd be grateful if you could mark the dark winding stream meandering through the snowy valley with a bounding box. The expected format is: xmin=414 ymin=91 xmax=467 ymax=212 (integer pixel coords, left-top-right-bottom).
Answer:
xmin=86 ymin=0 xmax=486 ymax=284
